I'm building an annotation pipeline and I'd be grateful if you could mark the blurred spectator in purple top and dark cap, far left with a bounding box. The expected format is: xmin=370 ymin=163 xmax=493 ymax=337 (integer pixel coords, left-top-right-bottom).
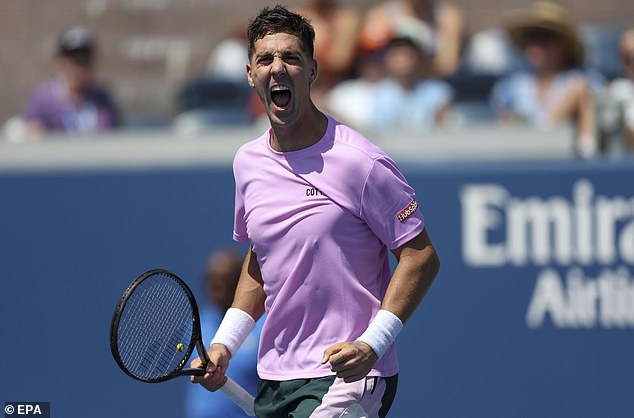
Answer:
xmin=23 ymin=26 xmax=119 ymax=138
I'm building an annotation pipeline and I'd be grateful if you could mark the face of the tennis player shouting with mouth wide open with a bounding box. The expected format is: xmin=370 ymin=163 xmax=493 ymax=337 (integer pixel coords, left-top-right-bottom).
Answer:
xmin=247 ymin=33 xmax=317 ymax=125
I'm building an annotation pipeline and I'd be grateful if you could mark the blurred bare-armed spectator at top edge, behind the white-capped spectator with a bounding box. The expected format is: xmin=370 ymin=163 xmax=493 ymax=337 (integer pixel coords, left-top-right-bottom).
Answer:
xmin=360 ymin=0 xmax=465 ymax=77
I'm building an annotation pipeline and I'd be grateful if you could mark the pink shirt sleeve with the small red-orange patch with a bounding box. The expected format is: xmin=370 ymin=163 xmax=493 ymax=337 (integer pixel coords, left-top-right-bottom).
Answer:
xmin=361 ymin=157 xmax=425 ymax=250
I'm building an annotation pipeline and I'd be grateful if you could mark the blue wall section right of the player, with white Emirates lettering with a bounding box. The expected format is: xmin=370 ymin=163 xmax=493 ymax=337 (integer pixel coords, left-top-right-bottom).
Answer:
xmin=394 ymin=161 xmax=634 ymax=417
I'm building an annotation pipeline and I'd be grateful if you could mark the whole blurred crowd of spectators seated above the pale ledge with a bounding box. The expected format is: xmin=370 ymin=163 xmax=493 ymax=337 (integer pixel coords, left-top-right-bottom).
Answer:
xmin=3 ymin=0 xmax=634 ymax=157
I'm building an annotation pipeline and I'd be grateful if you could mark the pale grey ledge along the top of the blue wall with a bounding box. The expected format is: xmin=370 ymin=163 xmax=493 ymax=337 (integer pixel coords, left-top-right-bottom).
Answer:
xmin=0 ymin=125 xmax=574 ymax=171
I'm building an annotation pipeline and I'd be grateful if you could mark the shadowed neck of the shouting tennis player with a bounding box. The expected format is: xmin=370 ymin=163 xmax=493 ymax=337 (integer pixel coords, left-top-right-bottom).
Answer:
xmin=271 ymin=106 xmax=328 ymax=152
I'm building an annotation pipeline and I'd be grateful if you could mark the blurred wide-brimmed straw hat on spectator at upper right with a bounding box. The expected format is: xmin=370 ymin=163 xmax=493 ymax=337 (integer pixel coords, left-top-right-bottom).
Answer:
xmin=504 ymin=1 xmax=583 ymax=67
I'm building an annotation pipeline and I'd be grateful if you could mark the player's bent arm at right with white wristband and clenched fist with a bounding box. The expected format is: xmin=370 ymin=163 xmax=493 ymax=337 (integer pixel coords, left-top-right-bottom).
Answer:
xmin=322 ymin=229 xmax=440 ymax=382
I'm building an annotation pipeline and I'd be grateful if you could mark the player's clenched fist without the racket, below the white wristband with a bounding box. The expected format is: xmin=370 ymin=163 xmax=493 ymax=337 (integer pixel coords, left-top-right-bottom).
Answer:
xmin=321 ymin=341 xmax=378 ymax=383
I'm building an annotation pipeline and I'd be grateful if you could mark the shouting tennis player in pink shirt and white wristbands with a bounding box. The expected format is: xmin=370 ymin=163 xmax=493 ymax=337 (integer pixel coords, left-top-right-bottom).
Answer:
xmin=192 ymin=6 xmax=439 ymax=418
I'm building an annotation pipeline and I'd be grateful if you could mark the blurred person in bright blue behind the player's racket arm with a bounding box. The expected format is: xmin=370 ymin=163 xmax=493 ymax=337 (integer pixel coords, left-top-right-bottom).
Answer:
xmin=185 ymin=250 xmax=264 ymax=418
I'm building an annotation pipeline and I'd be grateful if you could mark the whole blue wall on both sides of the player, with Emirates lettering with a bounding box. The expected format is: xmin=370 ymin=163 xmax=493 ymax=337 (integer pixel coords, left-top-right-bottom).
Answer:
xmin=0 ymin=161 xmax=634 ymax=418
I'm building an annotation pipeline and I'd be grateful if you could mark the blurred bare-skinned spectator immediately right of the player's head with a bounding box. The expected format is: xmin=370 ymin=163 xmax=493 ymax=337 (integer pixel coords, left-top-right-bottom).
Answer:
xmin=297 ymin=0 xmax=361 ymax=102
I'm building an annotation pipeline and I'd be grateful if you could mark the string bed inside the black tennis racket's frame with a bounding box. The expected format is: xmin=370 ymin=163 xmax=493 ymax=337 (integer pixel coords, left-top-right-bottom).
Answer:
xmin=117 ymin=275 xmax=193 ymax=379
